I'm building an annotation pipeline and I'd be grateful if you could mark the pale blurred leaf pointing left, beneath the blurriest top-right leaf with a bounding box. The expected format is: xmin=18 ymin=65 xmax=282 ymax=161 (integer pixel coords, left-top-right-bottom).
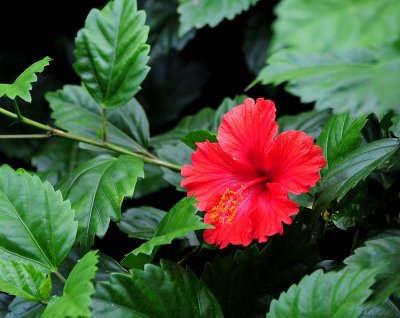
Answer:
xmin=255 ymin=47 xmax=400 ymax=116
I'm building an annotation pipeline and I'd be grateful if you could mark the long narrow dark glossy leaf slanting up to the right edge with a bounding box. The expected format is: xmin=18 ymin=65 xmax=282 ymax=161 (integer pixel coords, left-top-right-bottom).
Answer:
xmin=314 ymin=138 xmax=399 ymax=215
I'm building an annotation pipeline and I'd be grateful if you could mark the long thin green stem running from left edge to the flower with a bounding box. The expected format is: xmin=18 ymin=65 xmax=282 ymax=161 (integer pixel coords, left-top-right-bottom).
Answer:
xmin=0 ymin=107 xmax=182 ymax=171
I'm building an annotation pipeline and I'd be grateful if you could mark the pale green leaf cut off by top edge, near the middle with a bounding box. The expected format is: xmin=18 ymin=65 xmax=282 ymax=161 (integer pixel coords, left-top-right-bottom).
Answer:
xmin=178 ymin=0 xmax=258 ymax=36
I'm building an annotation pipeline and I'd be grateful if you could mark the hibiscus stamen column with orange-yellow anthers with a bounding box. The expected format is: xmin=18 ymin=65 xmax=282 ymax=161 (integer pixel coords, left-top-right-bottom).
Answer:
xmin=210 ymin=176 xmax=268 ymax=224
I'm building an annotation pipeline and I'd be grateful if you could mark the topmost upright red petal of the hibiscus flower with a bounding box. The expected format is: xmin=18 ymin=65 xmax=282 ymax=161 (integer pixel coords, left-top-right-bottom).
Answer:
xmin=218 ymin=98 xmax=278 ymax=170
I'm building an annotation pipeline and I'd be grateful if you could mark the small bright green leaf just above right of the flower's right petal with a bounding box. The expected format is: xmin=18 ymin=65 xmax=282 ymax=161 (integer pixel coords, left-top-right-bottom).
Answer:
xmin=317 ymin=113 xmax=367 ymax=170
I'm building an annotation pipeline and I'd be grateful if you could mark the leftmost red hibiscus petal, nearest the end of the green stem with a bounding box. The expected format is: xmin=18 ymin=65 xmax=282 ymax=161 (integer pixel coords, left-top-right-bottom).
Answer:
xmin=181 ymin=141 xmax=257 ymax=211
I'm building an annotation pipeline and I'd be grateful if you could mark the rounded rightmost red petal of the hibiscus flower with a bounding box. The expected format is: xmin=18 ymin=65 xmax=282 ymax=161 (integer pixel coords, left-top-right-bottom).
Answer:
xmin=265 ymin=131 xmax=326 ymax=194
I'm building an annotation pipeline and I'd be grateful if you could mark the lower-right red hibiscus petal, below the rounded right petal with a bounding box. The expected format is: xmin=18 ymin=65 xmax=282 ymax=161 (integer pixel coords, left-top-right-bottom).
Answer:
xmin=250 ymin=183 xmax=299 ymax=243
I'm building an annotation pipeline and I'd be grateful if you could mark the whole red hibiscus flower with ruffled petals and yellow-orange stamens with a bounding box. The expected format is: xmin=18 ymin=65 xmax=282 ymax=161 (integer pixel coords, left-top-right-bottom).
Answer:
xmin=182 ymin=98 xmax=326 ymax=248
